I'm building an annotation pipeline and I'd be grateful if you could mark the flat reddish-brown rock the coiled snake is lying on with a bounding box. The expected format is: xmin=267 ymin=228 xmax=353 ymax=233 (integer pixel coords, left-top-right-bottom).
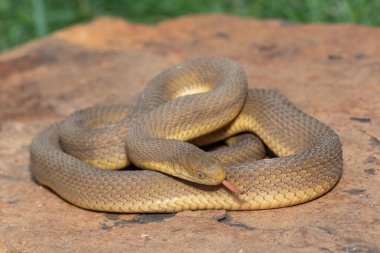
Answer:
xmin=0 ymin=15 xmax=380 ymax=253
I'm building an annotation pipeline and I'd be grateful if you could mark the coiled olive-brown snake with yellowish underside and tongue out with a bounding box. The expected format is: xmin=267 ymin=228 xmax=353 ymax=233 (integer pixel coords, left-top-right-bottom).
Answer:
xmin=30 ymin=57 xmax=343 ymax=213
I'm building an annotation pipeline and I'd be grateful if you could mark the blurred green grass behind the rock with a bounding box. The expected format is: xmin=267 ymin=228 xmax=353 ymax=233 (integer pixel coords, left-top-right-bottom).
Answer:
xmin=0 ymin=0 xmax=380 ymax=51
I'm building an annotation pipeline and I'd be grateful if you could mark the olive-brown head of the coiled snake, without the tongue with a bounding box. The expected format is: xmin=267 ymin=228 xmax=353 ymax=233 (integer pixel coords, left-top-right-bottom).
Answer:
xmin=185 ymin=150 xmax=226 ymax=185
